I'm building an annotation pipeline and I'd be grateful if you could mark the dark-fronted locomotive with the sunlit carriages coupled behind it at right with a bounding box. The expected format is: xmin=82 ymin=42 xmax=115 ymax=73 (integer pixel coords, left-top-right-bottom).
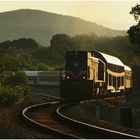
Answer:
xmin=60 ymin=51 xmax=132 ymax=100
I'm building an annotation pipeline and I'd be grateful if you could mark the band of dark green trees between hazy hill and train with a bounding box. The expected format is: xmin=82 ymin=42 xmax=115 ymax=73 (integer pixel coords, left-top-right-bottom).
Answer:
xmin=0 ymin=34 xmax=140 ymax=77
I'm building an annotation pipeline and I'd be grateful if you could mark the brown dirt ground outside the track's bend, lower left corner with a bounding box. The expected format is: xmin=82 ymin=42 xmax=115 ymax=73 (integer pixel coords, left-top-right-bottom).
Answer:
xmin=0 ymin=99 xmax=55 ymax=139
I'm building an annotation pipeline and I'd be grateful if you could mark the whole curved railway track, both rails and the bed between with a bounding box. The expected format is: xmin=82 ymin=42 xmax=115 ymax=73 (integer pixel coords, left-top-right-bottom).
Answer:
xmin=22 ymin=95 xmax=140 ymax=138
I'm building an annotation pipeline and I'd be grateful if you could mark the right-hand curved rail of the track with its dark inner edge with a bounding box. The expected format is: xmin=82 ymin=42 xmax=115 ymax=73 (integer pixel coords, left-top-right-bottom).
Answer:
xmin=56 ymin=104 xmax=140 ymax=139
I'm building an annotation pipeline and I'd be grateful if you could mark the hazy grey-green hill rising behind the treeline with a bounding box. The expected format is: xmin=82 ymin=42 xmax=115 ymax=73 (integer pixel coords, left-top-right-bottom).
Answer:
xmin=0 ymin=9 xmax=126 ymax=45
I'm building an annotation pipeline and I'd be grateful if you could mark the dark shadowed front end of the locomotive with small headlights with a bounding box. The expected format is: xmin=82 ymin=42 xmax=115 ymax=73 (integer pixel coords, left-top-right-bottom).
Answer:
xmin=60 ymin=51 xmax=93 ymax=100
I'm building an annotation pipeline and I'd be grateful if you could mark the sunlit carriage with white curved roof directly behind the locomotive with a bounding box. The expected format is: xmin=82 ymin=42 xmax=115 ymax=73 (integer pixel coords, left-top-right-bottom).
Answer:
xmin=93 ymin=51 xmax=125 ymax=94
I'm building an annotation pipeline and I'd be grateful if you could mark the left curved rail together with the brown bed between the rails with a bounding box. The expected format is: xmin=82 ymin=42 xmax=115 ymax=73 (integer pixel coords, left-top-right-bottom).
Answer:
xmin=22 ymin=101 xmax=87 ymax=138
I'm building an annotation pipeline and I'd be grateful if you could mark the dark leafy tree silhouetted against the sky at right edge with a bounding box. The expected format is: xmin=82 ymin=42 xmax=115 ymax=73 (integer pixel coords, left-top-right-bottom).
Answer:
xmin=127 ymin=4 xmax=140 ymax=46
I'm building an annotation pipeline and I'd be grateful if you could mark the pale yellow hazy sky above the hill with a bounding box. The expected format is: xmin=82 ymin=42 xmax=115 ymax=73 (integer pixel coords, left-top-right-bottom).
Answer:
xmin=0 ymin=0 xmax=140 ymax=30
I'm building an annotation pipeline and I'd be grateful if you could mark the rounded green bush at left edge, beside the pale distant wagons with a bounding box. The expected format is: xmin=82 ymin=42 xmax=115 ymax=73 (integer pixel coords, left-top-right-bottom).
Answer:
xmin=0 ymin=72 xmax=29 ymax=106
